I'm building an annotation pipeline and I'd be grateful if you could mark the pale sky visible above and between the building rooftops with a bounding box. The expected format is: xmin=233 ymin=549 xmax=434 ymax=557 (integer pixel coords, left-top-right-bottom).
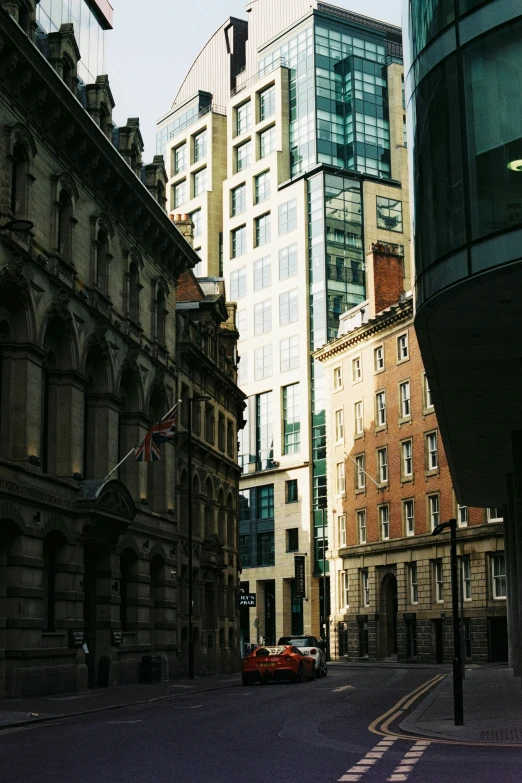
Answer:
xmin=107 ymin=0 xmax=402 ymax=163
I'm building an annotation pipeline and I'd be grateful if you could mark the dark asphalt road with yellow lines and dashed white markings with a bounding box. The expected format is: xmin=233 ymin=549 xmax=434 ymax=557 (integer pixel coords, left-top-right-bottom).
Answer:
xmin=0 ymin=667 xmax=522 ymax=783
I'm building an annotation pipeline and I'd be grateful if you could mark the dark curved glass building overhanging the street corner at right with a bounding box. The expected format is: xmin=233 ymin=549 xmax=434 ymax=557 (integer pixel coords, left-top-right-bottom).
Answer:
xmin=405 ymin=0 xmax=522 ymax=675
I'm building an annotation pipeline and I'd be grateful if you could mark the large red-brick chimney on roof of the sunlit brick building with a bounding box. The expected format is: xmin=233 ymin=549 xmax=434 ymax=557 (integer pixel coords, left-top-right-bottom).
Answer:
xmin=366 ymin=242 xmax=404 ymax=318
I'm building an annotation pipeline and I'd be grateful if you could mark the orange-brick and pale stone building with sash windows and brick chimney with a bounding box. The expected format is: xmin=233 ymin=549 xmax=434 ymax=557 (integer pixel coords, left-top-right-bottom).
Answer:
xmin=315 ymin=245 xmax=507 ymax=663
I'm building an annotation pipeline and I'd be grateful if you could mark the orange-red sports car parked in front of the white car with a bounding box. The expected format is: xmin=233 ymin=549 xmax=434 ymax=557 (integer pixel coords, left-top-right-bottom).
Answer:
xmin=241 ymin=644 xmax=315 ymax=685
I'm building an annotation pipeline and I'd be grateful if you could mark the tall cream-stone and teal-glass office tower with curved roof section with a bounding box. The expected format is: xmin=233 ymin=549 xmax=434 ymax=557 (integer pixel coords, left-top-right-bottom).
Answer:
xmin=157 ymin=0 xmax=410 ymax=642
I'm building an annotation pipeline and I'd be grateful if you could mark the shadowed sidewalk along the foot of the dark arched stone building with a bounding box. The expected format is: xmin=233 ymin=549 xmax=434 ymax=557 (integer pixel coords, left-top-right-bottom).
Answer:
xmin=0 ymin=673 xmax=241 ymax=732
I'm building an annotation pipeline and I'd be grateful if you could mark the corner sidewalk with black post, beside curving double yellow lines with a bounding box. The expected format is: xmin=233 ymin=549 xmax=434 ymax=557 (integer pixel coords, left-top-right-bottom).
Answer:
xmin=399 ymin=664 xmax=522 ymax=744
